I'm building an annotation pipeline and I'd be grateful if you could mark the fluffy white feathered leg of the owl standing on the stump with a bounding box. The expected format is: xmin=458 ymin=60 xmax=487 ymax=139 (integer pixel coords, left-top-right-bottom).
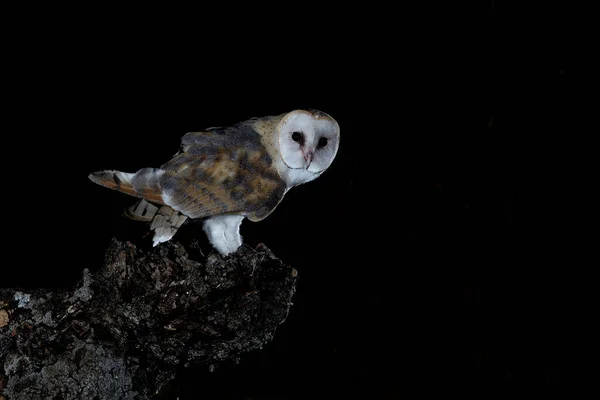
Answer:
xmin=203 ymin=215 xmax=245 ymax=256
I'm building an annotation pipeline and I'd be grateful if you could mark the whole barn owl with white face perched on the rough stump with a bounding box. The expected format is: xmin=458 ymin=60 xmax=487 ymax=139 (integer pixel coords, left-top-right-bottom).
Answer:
xmin=89 ymin=110 xmax=340 ymax=256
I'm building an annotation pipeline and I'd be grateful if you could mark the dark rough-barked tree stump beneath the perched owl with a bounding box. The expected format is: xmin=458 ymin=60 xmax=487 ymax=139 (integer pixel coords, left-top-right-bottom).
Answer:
xmin=0 ymin=239 xmax=296 ymax=400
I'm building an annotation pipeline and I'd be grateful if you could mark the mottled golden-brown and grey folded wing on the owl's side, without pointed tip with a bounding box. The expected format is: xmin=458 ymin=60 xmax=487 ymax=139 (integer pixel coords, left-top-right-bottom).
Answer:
xmin=158 ymin=125 xmax=286 ymax=221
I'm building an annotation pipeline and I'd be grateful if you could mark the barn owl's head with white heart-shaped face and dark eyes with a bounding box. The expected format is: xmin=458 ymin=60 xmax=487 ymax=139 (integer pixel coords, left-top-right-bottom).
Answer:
xmin=277 ymin=110 xmax=340 ymax=174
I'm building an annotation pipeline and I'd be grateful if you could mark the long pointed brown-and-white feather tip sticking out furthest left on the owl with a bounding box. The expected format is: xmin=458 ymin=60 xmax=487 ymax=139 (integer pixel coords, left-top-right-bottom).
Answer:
xmin=88 ymin=168 xmax=165 ymax=204
